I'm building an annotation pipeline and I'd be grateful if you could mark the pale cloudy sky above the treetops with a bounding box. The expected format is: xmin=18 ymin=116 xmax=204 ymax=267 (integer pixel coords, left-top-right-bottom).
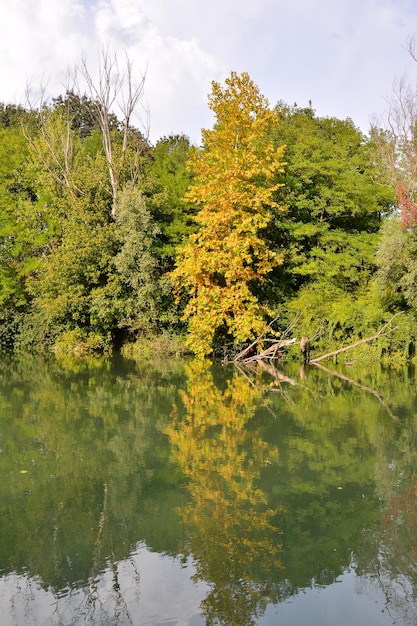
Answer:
xmin=0 ymin=0 xmax=417 ymax=144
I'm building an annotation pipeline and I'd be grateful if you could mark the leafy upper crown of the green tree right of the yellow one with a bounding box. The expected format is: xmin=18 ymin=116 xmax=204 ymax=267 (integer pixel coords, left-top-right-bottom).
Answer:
xmin=276 ymin=105 xmax=392 ymax=291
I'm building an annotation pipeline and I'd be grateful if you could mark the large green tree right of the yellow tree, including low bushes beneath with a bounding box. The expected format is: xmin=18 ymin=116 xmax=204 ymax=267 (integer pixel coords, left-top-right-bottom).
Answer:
xmin=267 ymin=103 xmax=393 ymax=341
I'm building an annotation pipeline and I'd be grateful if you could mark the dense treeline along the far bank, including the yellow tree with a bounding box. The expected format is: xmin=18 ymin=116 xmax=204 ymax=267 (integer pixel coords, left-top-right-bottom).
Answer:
xmin=0 ymin=64 xmax=417 ymax=357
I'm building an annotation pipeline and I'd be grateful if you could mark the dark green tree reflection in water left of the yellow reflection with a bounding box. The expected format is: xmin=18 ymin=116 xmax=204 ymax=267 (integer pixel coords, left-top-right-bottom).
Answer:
xmin=0 ymin=354 xmax=188 ymax=626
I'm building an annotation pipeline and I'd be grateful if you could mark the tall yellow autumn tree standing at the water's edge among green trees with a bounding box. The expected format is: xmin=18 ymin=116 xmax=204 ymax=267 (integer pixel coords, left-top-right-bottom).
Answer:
xmin=173 ymin=72 xmax=283 ymax=356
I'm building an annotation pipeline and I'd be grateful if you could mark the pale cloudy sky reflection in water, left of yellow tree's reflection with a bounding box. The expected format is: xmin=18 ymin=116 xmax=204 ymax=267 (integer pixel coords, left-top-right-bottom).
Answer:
xmin=0 ymin=544 xmax=207 ymax=626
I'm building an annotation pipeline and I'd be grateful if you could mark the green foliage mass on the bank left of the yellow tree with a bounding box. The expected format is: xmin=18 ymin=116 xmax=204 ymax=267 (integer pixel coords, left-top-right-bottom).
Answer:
xmin=0 ymin=92 xmax=177 ymax=351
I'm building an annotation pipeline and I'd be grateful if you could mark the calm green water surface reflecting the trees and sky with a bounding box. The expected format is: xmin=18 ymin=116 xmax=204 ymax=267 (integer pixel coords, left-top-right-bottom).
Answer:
xmin=0 ymin=357 xmax=417 ymax=626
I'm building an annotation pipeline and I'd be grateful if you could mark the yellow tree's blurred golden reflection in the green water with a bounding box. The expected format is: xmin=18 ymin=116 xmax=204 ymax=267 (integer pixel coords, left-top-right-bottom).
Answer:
xmin=168 ymin=362 xmax=281 ymax=626
